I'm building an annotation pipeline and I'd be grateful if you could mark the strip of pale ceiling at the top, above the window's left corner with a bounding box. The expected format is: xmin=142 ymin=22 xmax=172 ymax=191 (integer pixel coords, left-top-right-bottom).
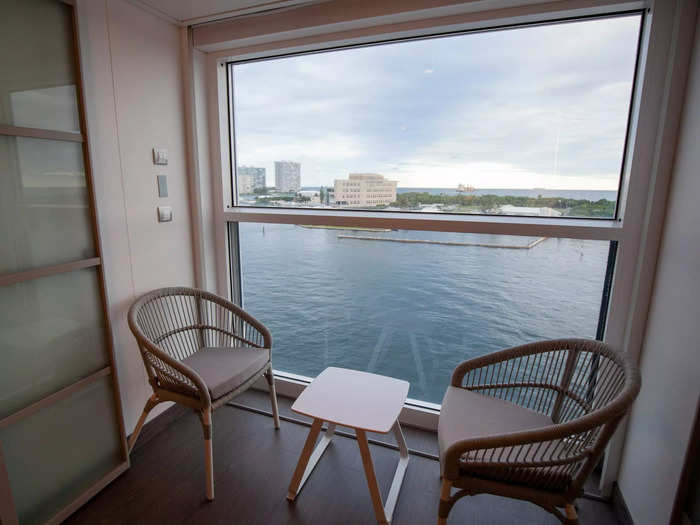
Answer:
xmin=129 ymin=0 xmax=316 ymax=25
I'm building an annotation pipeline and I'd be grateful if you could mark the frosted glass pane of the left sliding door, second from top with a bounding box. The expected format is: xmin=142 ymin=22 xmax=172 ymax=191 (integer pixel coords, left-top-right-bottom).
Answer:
xmin=0 ymin=136 xmax=95 ymax=273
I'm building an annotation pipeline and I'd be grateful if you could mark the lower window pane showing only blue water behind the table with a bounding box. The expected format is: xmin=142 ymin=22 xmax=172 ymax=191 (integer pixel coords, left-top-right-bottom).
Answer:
xmin=239 ymin=223 xmax=609 ymax=403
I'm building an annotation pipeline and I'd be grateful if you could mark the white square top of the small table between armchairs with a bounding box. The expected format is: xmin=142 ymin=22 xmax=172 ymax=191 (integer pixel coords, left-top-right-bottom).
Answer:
xmin=292 ymin=367 xmax=409 ymax=434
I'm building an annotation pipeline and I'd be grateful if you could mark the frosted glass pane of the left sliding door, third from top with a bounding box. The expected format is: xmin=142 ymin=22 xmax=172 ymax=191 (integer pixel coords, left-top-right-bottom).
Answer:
xmin=0 ymin=268 xmax=108 ymax=418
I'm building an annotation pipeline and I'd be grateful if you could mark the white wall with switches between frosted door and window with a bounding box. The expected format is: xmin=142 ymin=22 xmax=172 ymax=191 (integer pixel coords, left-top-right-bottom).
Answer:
xmin=77 ymin=0 xmax=194 ymax=433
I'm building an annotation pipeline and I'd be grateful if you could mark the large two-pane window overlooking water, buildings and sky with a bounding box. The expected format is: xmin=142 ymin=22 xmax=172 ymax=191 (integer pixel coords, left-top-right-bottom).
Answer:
xmin=225 ymin=12 xmax=642 ymax=403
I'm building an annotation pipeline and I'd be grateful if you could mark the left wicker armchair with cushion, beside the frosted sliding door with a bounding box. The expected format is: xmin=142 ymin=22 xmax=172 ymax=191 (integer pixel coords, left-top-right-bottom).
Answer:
xmin=129 ymin=288 xmax=279 ymax=500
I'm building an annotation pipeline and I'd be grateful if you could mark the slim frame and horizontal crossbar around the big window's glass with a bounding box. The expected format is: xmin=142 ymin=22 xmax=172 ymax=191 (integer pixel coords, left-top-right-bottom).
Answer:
xmin=222 ymin=9 xmax=646 ymax=408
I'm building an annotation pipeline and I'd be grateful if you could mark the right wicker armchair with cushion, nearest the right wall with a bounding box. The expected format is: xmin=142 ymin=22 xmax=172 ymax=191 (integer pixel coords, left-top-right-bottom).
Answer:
xmin=438 ymin=339 xmax=640 ymax=525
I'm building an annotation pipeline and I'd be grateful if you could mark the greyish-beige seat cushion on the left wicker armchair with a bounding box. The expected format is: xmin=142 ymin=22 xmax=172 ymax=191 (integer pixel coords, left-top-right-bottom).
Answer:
xmin=182 ymin=347 xmax=270 ymax=401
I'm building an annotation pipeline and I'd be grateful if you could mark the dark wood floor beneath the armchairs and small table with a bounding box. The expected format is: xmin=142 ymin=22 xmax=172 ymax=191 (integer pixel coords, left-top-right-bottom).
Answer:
xmin=67 ymin=392 xmax=617 ymax=525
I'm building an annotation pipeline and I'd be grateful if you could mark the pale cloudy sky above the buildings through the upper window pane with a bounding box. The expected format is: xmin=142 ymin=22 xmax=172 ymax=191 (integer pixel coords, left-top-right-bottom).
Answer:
xmin=233 ymin=15 xmax=640 ymax=190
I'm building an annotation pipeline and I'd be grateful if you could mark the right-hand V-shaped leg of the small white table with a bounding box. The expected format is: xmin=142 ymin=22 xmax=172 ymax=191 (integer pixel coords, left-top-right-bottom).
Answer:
xmin=355 ymin=421 xmax=408 ymax=525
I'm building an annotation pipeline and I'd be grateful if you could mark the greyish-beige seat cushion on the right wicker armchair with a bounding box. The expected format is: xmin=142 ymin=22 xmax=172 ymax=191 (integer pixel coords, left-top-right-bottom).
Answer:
xmin=438 ymin=386 xmax=552 ymax=460
